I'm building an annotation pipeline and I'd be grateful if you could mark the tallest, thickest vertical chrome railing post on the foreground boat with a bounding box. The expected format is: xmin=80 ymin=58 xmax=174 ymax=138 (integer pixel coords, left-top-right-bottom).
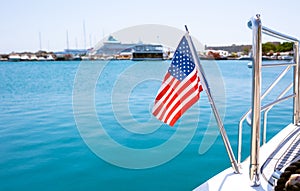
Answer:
xmin=249 ymin=15 xmax=262 ymax=186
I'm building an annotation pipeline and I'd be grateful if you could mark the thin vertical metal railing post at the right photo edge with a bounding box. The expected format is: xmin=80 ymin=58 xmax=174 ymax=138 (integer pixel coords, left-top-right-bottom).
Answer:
xmin=293 ymin=41 xmax=300 ymax=125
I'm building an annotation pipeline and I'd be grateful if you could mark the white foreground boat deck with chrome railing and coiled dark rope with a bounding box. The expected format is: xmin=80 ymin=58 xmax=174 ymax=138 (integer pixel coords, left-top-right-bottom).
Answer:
xmin=194 ymin=15 xmax=300 ymax=191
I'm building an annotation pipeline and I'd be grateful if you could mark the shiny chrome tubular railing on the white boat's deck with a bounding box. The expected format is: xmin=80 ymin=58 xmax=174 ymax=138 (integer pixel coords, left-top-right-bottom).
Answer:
xmin=238 ymin=15 xmax=300 ymax=186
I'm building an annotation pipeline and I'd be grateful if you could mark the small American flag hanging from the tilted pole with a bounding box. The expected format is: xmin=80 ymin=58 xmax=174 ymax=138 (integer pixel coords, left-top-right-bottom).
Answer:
xmin=152 ymin=36 xmax=202 ymax=126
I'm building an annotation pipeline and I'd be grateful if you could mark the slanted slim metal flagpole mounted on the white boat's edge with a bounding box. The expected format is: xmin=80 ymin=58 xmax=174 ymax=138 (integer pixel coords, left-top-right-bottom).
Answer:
xmin=185 ymin=26 xmax=240 ymax=173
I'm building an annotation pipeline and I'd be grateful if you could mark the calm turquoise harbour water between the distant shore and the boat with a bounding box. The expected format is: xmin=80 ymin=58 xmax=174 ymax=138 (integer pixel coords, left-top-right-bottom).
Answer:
xmin=0 ymin=61 xmax=292 ymax=191
